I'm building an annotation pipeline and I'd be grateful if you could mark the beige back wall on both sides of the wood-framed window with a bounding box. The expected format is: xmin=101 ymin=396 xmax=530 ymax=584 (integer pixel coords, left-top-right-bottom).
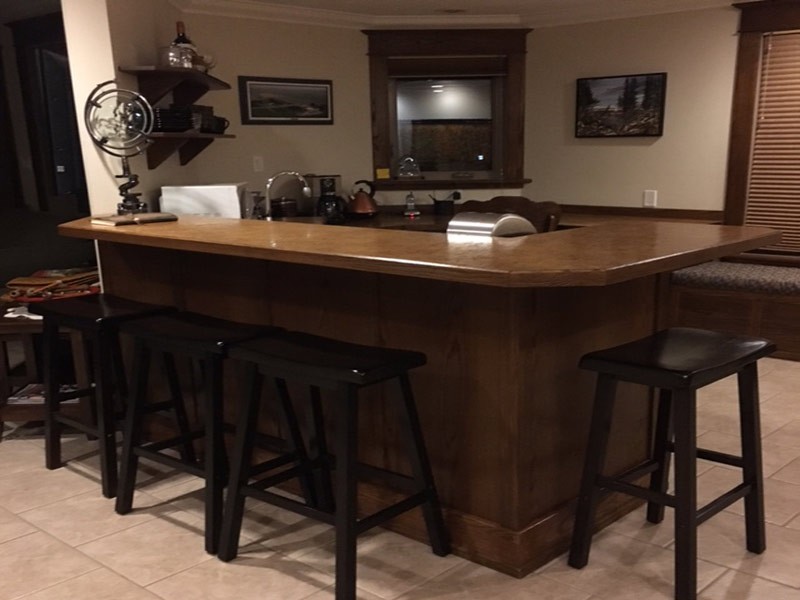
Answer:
xmin=63 ymin=0 xmax=738 ymax=212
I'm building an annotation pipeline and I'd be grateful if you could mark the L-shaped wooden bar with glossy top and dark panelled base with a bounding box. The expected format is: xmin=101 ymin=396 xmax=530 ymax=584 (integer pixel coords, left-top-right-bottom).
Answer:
xmin=59 ymin=216 xmax=779 ymax=576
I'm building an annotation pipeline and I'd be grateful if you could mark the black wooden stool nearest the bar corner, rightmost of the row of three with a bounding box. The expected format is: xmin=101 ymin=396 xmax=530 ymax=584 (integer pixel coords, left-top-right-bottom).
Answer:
xmin=218 ymin=332 xmax=450 ymax=600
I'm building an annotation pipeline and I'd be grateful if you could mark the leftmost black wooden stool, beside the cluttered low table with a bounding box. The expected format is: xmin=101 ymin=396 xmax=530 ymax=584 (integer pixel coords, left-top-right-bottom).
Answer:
xmin=28 ymin=294 xmax=175 ymax=498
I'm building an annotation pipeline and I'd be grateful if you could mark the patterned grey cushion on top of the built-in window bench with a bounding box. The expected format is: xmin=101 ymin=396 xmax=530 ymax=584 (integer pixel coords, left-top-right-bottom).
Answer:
xmin=672 ymin=261 xmax=800 ymax=295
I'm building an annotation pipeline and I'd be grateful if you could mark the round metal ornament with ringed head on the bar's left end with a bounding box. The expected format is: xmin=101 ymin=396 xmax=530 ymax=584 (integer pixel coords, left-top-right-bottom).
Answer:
xmin=83 ymin=80 xmax=153 ymax=215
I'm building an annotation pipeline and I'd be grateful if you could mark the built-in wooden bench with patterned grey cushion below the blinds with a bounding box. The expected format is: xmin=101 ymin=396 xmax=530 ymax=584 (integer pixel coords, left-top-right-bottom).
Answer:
xmin=669 ymin=261 xmax=800 ymax=360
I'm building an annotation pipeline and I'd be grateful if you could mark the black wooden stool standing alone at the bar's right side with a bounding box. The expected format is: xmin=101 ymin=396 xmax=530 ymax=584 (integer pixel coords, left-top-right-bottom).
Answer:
xmin=568 ymin=327 xmax=775 ymax=600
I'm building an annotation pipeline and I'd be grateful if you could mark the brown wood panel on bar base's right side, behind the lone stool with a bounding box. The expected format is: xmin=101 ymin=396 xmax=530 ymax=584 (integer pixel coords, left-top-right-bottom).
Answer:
xmin=517 ymin=278 xmax=655 ymax=523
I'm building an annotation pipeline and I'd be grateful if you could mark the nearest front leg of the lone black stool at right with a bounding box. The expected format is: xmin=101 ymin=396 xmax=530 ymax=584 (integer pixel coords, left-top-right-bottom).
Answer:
xmin=673 ymin=389 xmax=697 ymax=600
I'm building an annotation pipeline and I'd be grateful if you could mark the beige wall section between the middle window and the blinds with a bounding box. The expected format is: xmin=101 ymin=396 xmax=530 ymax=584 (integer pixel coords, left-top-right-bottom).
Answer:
xmin=525 ymin=8 xmax=739 ymax=210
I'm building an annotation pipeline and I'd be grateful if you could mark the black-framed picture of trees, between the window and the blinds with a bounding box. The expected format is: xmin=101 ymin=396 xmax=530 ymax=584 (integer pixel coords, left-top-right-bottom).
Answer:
xmin=575 ymin=73 xmax=667 ymax=138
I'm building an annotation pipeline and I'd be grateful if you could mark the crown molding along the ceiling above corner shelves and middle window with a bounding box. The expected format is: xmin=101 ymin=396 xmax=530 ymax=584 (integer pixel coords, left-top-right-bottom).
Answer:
xmin=169 ymin=0 xmax=522 ymax=29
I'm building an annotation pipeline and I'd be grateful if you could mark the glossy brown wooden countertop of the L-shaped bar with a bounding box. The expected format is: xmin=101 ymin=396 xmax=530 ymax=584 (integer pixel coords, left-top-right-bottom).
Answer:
xmin=59 ymin=215 xmax=780 ymax=287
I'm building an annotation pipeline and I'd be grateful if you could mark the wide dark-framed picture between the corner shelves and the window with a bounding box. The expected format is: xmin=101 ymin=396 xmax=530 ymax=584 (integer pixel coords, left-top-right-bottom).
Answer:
xmin=238 ymin=75 xmax=333 ymax=125
